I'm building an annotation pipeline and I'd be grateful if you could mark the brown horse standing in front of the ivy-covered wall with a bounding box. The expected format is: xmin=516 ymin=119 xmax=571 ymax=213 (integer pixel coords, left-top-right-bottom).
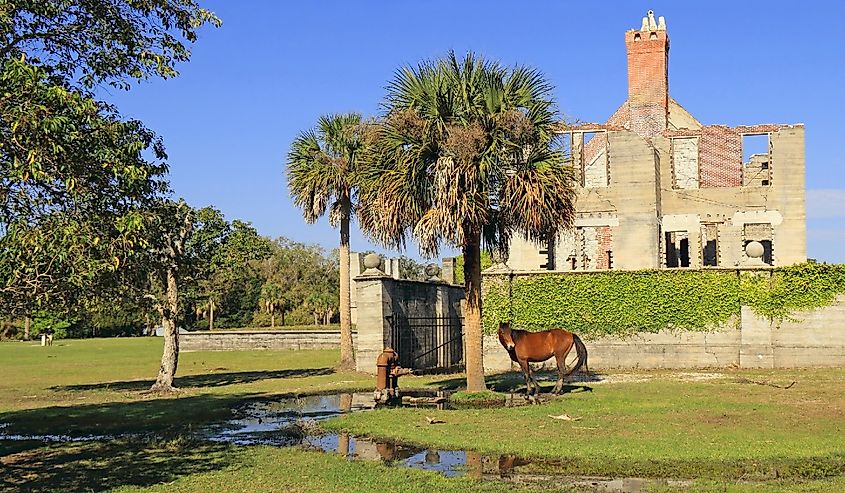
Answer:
xmin=499 ymin=322 xmax=589 ymax=395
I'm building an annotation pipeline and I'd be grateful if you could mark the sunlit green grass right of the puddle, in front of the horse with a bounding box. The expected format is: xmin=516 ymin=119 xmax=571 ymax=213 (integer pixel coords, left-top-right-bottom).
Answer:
xmin=324 ymin=369 xmax=845 ymax=479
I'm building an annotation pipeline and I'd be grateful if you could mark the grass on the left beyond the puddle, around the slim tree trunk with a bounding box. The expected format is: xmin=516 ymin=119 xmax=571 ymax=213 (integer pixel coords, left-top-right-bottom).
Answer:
xmin=0 ymin=337 xmax=430 ymax=434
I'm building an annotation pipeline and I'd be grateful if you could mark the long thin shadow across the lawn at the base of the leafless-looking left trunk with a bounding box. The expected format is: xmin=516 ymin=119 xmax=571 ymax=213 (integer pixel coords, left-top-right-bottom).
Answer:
xmin=50 ymin=368 xmax=334 ymax=392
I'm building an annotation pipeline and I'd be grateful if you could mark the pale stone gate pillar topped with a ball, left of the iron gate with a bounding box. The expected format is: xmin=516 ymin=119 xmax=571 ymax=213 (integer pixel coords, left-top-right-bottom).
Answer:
xmin=354 ymin=254 xmax=393 ymax=374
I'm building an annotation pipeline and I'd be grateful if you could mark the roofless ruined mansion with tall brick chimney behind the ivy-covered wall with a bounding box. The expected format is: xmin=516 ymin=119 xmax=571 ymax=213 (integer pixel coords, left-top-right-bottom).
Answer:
xmin=508 ymin=11 xmax=807 ymax=271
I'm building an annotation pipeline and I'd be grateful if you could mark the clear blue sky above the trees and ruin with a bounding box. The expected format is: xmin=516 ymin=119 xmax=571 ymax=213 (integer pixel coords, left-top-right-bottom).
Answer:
xmin=103 ymin=0 xmax=845 ymax=262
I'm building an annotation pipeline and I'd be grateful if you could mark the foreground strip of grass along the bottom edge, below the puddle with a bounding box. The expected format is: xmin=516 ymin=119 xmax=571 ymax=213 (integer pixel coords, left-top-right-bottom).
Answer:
xmin=8 ymin=440 xmax=845 ymax=493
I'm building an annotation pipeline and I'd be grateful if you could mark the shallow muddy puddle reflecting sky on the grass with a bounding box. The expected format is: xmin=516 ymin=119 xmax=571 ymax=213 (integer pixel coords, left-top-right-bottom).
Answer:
xmin=0 ymin=390 xmax=689 ymax=493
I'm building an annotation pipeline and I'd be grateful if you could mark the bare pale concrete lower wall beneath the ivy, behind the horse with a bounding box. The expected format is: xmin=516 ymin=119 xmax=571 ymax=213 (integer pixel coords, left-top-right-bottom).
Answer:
xmin=484 ymin=296 xmax=845 ymax=373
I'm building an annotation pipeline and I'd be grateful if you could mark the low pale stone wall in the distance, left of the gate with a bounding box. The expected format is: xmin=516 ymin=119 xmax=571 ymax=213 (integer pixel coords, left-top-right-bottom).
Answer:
xmin=179 ymin=330 xmax=357 ymax=351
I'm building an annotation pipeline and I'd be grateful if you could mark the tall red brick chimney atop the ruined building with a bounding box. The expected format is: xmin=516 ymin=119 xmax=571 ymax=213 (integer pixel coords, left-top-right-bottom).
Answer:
xmin=625 ymin=10 xmax=669 ymax=138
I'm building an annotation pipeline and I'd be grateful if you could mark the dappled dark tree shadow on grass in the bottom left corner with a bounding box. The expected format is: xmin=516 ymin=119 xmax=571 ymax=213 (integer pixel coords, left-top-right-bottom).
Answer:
xmin=0 ymin=437 xmax=238 ymax=491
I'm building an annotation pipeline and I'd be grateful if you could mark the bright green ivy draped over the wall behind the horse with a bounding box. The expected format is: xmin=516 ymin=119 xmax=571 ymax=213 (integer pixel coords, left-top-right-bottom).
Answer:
xmin=483 ymin=264 xmax=845 ymax=337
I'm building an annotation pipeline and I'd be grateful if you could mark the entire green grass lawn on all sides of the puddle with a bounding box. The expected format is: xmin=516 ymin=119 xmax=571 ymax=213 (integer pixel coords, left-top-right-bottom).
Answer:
xmin=0 ymin=338 xmax=845 ymax=492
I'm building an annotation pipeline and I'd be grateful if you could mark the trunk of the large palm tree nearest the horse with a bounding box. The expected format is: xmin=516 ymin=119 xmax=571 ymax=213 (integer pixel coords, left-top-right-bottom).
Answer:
xmin=463 ymin=231 xmax=487 ymax=392
